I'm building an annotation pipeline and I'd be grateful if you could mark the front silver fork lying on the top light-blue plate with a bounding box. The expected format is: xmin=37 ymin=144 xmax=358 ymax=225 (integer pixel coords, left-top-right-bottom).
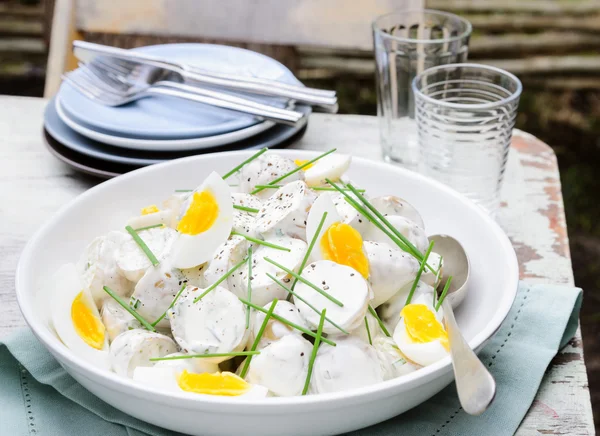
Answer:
xmin=62 ymin=64 xmax=304 ymax=126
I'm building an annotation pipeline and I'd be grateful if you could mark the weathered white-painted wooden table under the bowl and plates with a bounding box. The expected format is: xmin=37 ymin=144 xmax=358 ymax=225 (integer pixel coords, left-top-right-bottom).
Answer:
xmin=0 ymin=97 xmax=594 ymax=435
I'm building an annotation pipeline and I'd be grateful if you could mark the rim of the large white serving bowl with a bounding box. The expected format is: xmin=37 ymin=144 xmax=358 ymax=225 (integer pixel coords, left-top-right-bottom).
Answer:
xmin=15 ymin=150 xmax=519 ymax=413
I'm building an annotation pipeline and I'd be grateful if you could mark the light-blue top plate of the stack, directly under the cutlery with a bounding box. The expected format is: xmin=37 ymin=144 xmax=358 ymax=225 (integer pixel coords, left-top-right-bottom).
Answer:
xmin=59 ymin=44 xmax=301 ymax=139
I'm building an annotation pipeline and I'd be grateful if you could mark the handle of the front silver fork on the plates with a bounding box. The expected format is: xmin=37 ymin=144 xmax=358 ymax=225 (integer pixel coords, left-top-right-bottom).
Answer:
xmin=146 ymin=86 xmax=304 ymax=126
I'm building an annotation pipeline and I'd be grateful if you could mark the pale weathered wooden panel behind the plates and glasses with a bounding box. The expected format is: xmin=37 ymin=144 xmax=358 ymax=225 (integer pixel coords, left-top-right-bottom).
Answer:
xmin=76 ymin=0 xmax=423 ymax=48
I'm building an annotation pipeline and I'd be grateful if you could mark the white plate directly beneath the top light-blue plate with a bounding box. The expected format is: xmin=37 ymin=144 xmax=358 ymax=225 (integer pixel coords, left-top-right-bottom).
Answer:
xmin=56 ymin=96 xmax=275 ymax=151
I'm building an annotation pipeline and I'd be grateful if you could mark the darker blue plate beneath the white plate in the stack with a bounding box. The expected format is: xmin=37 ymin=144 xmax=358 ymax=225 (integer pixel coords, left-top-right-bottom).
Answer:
xmin=44 ymin=99 xmax=311 ymax=166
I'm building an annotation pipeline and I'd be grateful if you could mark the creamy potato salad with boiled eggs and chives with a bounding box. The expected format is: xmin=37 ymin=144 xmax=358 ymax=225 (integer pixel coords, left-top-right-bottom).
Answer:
xmin=48 ymin=149 xmax=449 ymax=398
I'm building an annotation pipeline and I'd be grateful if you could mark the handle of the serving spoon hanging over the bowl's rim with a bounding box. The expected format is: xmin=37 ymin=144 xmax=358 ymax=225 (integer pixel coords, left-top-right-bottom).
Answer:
xmin=442 ymin=298 xmax=496 ymax=415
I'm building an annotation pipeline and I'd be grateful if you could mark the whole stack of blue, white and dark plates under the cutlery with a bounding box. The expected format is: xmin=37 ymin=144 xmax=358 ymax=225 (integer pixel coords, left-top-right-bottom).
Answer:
xmin=44 ymin=44 xmax=311 ymax=177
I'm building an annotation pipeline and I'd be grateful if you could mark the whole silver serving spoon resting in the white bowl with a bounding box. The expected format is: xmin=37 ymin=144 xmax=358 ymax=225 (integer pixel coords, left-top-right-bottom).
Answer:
xmin=429 ymin=235 xmax=496 ymax=415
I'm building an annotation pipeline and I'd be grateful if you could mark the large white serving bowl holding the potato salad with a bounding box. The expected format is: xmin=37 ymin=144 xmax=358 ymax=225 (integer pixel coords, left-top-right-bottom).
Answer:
xmin=16 ymin=150 xmax=518 ymax=436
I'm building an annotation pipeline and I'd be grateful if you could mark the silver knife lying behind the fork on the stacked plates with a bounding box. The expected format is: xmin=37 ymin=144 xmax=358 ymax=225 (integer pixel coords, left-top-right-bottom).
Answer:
xmin=73 ymin=41 xmax=338 ymax=112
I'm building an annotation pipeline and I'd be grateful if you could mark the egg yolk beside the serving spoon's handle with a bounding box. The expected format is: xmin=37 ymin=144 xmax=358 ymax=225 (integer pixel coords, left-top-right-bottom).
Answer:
xmin=400 ymin=304 xmax=449 ymax=350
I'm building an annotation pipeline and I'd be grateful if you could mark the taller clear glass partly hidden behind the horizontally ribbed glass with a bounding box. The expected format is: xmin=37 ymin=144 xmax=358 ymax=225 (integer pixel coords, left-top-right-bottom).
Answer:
xmin=373 ymin=9 xmax=471 ymax=170
